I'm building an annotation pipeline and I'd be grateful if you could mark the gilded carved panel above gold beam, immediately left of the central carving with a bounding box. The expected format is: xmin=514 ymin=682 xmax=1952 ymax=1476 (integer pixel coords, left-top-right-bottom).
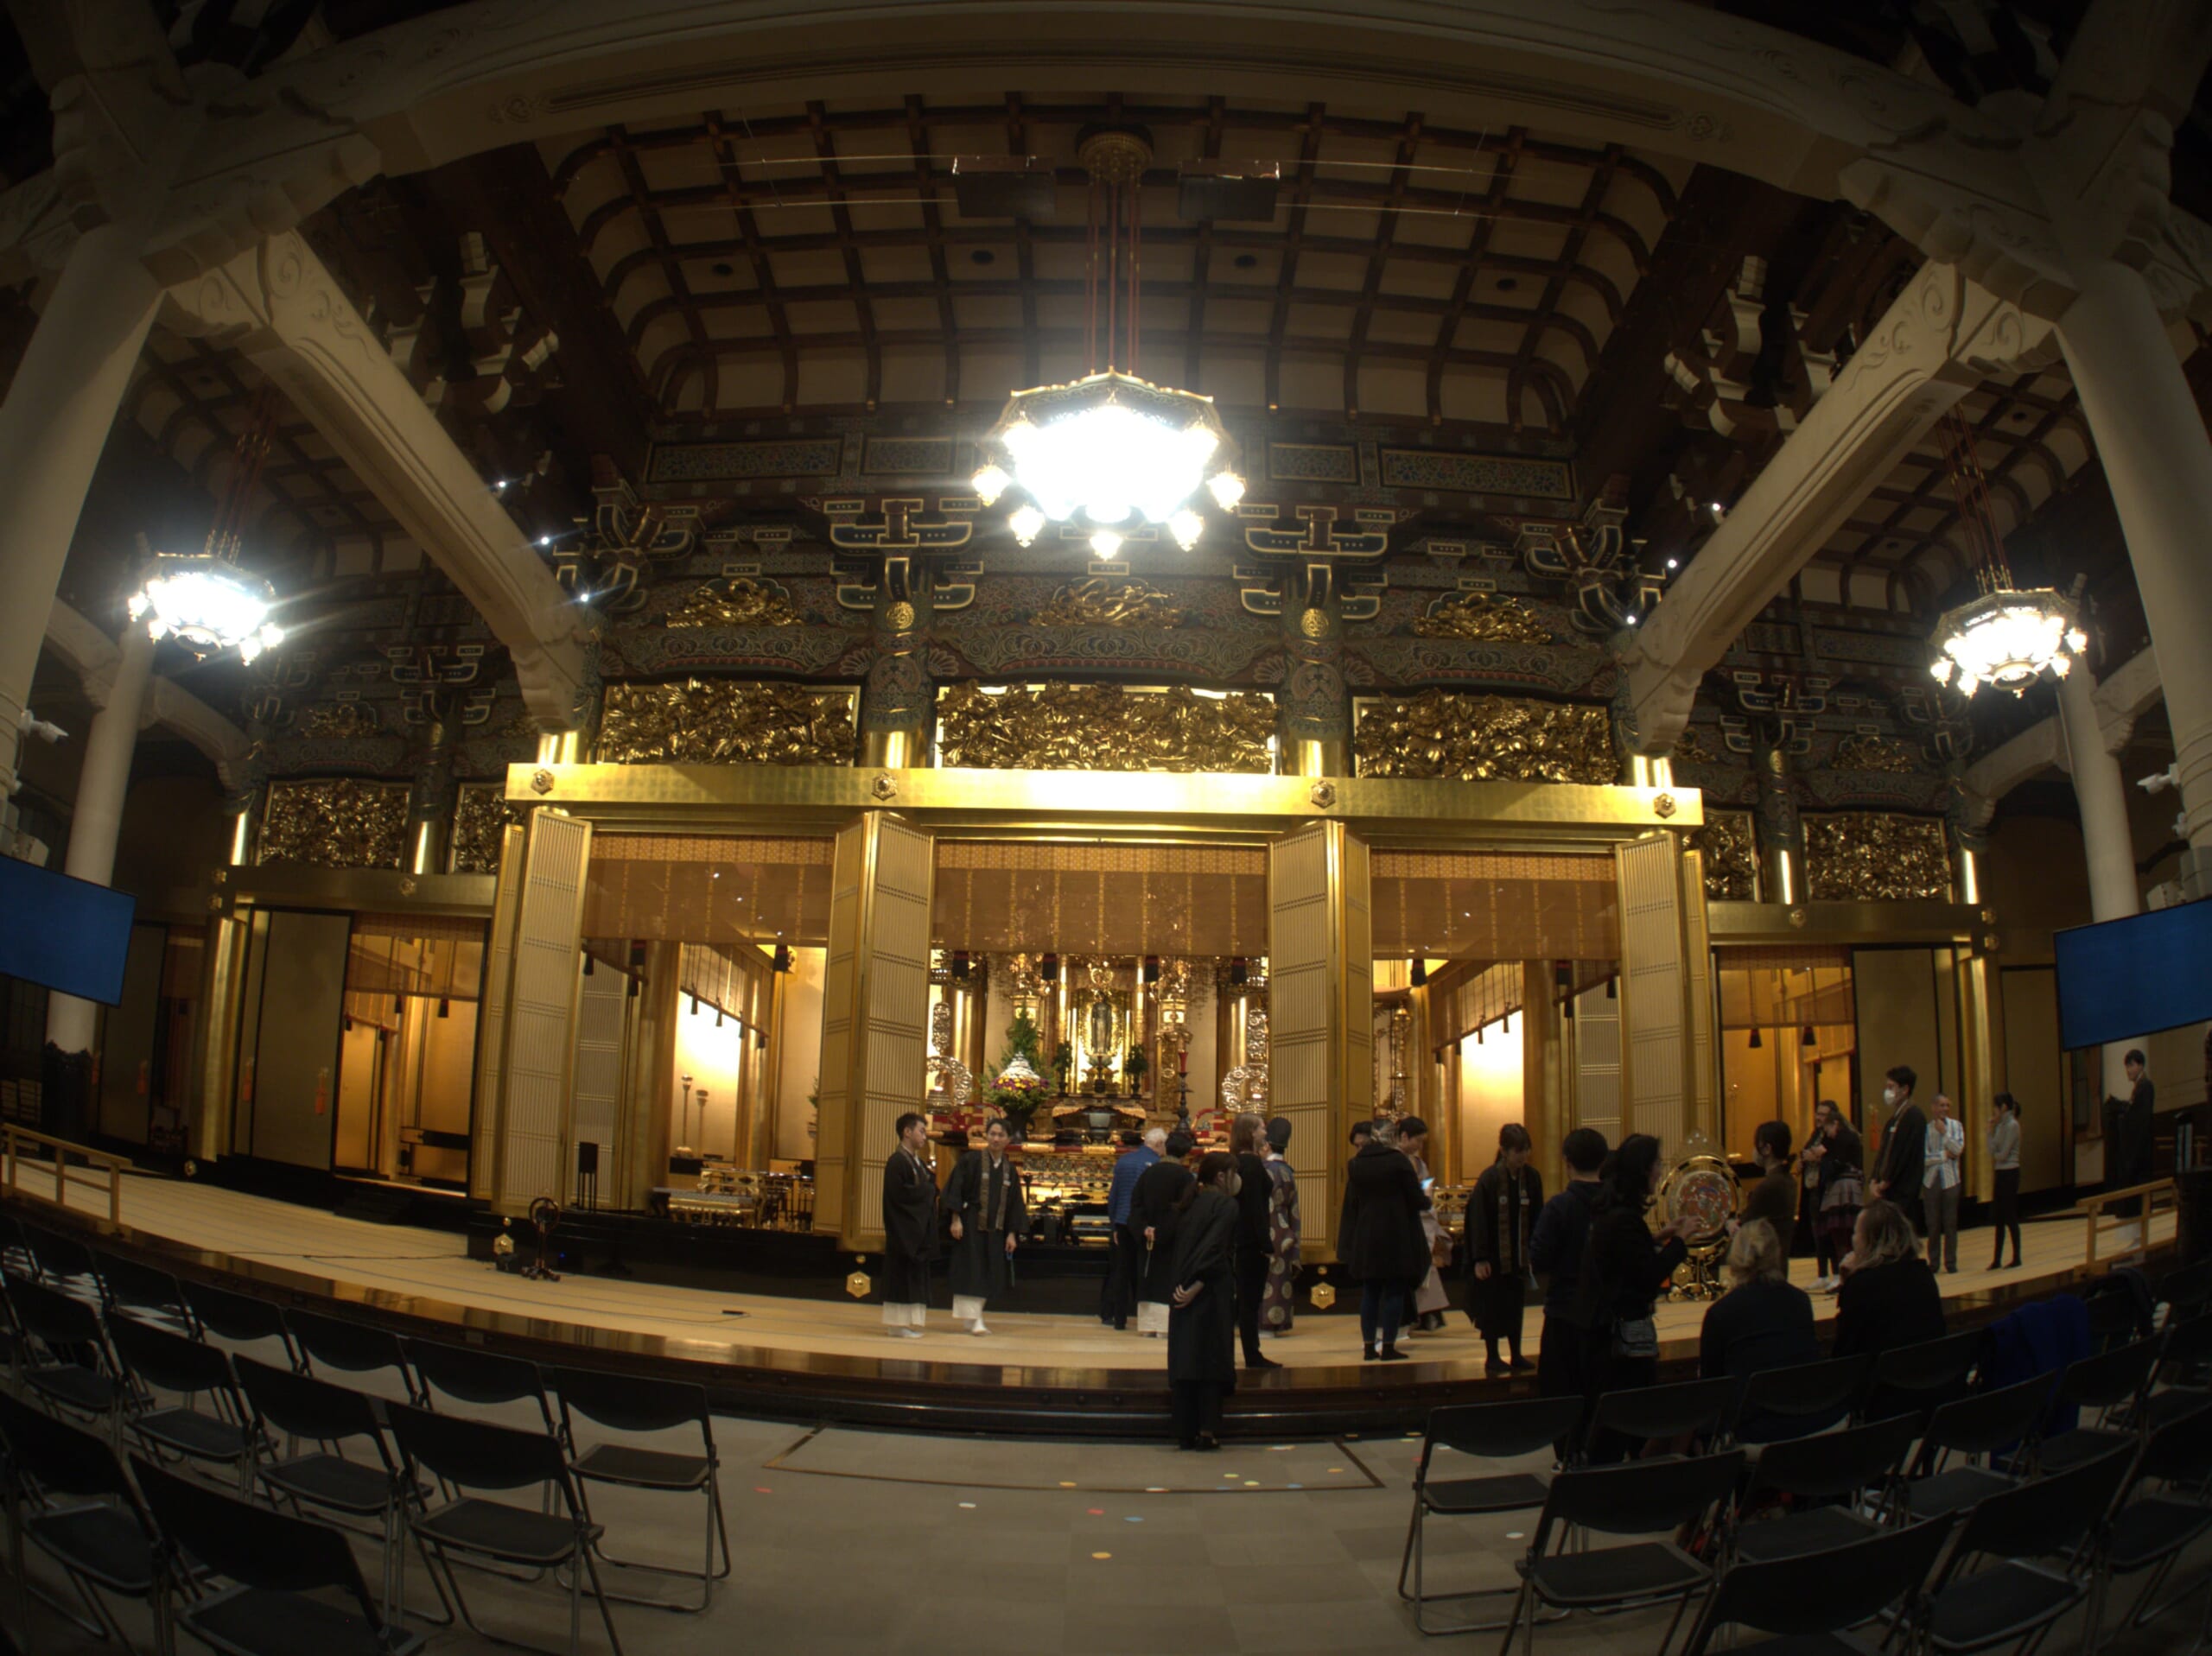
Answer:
xmin=600 ymin=679 xmax=854 ymax=765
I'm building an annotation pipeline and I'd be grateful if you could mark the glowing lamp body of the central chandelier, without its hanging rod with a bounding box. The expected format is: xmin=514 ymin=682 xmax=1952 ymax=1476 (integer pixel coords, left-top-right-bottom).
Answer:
xmin=973 ymin=369 xmax=1243 ymax=557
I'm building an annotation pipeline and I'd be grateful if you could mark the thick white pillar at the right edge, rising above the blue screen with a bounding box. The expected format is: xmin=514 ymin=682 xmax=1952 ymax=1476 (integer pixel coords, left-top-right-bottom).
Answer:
xmin=2057 ymin=261 xmax=2212 ymax=896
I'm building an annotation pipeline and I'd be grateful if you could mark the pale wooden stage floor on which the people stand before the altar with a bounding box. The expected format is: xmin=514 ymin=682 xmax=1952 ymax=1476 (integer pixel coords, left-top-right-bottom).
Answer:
xmin=13 ymin=1177 xmax=2174 ymax=1435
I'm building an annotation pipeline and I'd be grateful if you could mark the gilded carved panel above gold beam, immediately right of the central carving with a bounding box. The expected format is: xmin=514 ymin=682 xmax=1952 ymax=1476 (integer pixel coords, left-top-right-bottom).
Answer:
xmin=1351 ymin=690 xmax=1619 ymax=785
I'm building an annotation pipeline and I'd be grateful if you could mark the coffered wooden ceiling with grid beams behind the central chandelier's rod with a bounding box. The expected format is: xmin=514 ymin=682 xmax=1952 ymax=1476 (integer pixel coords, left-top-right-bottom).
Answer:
xmin=544 ymin=92 xmax=1688 ymax=435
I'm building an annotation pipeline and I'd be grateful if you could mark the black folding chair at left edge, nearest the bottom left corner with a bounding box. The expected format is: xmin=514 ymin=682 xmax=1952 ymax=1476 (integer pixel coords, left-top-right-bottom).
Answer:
xmin=0 ymin=1393 xmax=168 ymax=1652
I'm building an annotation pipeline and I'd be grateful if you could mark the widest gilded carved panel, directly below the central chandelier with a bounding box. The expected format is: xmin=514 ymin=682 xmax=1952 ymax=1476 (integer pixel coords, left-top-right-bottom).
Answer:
xmin=938 ymin=683 xmax=1274 ymax=776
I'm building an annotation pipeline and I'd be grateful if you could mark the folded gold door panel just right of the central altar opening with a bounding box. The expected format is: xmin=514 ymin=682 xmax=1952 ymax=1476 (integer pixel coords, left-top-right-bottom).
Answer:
xmin=1268 ymin=822 xmax=1376 ymax=1260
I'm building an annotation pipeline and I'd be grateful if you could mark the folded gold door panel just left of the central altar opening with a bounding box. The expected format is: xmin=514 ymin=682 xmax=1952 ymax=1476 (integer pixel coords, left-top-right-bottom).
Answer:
xmin=814 ymin=811 xmax=936 ymax=1249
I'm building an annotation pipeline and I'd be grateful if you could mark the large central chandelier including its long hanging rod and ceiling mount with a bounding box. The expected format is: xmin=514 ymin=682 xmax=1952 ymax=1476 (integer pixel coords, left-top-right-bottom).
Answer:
xmin=973 ymin=130 xmax=1243 ymax=557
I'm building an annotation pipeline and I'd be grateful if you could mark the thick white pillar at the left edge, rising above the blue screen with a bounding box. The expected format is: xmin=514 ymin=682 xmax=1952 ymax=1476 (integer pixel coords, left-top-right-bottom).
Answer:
xmin=0 ymin=224 xmax=162 ymax=794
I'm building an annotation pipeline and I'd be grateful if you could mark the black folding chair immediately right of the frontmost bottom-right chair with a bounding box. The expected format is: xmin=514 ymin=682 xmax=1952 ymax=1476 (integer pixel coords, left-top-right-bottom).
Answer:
xmin=1927 ymin=1446 xmax=2134 ymax=1656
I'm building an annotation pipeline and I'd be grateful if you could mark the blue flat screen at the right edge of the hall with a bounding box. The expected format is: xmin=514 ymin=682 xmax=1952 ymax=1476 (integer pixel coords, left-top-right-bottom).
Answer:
xmin=2050 ymin=900 xmax=2212 ymax=1050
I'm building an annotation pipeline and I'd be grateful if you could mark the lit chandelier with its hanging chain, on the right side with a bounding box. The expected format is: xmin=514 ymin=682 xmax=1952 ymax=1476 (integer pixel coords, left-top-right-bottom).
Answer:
xmin=1929 ymin=409 xmax=2088 ymax=696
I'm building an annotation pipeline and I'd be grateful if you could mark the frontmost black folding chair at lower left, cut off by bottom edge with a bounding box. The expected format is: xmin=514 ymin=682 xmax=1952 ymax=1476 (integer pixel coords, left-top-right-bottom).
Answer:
xmin=130 ymin=1457 xmax=425 ymax=1656
